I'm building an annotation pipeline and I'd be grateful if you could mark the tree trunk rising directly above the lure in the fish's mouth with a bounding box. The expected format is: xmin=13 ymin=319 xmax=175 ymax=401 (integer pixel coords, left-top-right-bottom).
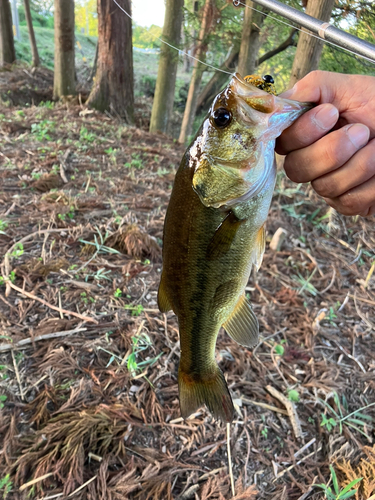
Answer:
xmin=237 ymin=0 xmax=266 ymax=77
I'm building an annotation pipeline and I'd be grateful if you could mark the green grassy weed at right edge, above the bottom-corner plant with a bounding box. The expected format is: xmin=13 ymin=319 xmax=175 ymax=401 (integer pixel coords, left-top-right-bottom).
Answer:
xmin=319 ymin=393 xmax=375 ymax=442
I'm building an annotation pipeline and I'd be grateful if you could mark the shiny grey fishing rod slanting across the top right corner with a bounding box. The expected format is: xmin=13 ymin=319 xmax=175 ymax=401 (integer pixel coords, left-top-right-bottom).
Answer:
xmin=233 ymin=0 xmax=375 ymax=63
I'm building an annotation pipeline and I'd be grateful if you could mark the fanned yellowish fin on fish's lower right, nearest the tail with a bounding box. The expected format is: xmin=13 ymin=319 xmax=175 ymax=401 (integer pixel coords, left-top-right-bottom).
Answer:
xmin=223 ymin=295 xmax=259 ymax=347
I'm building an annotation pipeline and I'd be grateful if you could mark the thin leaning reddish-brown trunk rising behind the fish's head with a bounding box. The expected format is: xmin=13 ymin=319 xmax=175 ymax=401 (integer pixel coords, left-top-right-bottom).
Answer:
xmin=178 ymin=0 xmax=212 ymax=143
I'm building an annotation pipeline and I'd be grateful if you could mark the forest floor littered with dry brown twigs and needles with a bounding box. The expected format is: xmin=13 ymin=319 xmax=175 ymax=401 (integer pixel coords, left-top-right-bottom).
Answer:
xmin=0 ymin=69 xmax=375 ymax=500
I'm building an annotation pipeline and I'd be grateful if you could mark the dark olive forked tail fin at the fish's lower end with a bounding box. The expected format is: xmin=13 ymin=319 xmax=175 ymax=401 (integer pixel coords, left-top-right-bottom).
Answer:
xmin=178 ymin=365 xmax=234 ymax=422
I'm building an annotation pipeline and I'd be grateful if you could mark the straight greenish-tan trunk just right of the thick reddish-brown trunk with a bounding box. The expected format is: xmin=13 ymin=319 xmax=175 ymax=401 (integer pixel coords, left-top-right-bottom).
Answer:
xmin=150 ymin=0 xmax=184 ymax=134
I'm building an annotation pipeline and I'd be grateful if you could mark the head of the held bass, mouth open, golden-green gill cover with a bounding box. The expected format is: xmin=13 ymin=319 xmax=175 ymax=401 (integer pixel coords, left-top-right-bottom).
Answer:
xmin=190 ymin=73 xmax=311 ymax=208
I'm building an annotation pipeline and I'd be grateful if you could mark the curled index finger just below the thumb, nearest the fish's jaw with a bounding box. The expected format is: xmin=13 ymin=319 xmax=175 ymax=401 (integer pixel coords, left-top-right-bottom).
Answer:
xmin=275 ymin=104 xmax=339 ymax=155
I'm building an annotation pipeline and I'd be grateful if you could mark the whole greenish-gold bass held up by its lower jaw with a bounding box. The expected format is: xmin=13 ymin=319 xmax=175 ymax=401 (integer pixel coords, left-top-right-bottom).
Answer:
xmin=158 ymin=73 xmax=312 ymax=422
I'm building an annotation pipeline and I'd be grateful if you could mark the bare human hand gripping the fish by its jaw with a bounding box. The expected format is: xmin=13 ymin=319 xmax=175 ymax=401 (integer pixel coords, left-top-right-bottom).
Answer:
xmin=276 ymin=71 xmax=375 ymax=217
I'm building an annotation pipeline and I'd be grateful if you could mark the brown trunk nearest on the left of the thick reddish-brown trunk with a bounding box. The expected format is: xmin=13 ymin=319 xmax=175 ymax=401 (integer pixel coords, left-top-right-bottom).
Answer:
xmin=53 ymin=0 xmax=76 ymax=99
